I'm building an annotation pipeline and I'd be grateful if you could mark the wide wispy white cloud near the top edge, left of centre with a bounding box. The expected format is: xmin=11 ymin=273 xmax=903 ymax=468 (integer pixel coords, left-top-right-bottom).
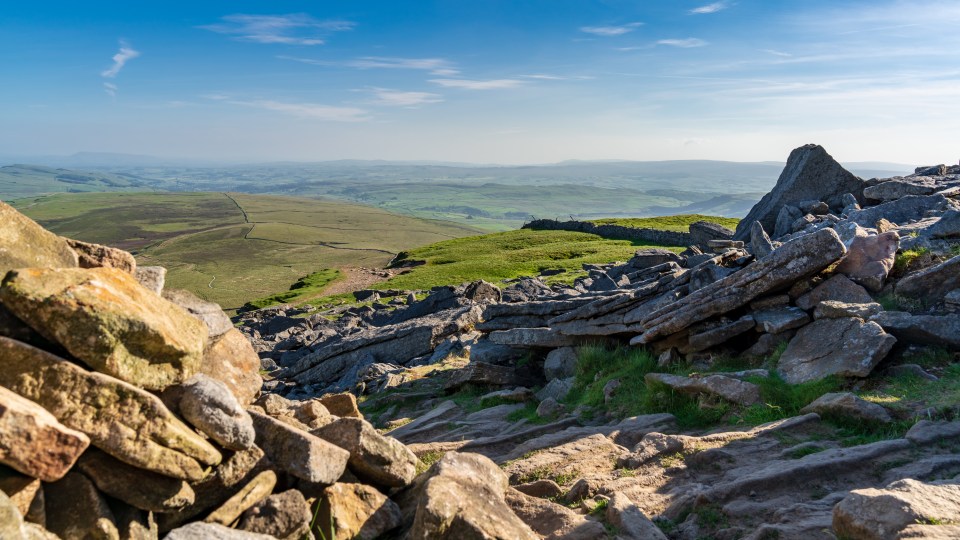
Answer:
xmin=200 ymin=13 xmax=355 ymax=45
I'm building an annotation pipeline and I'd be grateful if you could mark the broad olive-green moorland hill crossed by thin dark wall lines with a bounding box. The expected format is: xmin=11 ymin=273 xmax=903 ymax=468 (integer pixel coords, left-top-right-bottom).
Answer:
xmin=12 ymin=193 xmax=478 ymax=310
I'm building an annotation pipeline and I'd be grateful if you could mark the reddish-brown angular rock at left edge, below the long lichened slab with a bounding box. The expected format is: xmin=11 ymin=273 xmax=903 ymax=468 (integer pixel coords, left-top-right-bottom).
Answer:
xmin=0 ymin=386 xmax=90 ymax=482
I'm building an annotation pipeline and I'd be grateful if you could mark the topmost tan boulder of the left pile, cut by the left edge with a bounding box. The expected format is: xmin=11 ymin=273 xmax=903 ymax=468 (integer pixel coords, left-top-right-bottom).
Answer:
xmin=0 ymin=201 xmax=78 ymax=279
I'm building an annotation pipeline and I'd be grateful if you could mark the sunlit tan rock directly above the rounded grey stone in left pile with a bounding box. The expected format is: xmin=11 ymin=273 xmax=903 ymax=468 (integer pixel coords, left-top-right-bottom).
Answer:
xmin=200 ymin=328 xmax=263 ymax=407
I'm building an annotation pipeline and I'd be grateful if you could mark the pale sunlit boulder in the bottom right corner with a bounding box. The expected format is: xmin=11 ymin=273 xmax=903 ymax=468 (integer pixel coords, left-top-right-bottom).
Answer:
xmin=833 ymin=478 xmax=960 ymax=540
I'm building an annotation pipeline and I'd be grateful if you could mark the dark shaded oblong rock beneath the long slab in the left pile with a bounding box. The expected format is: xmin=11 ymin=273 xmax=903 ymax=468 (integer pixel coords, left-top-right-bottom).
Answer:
xmin=77 ymin=449 xmax=195 ymax=512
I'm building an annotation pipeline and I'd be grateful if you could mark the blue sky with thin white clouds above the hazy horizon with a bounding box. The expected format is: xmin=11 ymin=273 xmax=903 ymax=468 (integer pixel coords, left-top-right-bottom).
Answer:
xmin=0 ymin=0 xmax=960 ymax=164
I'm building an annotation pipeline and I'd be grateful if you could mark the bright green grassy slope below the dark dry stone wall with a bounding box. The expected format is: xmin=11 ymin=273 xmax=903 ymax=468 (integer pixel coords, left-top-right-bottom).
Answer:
xmin=374 ymin=229 xmax=684 ymax=296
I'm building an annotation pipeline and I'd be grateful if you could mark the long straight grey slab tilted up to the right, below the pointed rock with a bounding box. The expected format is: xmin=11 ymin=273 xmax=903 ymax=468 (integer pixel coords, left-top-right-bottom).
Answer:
xmin=624 ymin=229 xmax=846 ymax=344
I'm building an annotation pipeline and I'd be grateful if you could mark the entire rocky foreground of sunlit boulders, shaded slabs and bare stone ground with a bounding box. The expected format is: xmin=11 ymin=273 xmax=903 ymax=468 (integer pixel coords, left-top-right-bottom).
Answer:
xmin=0 ymin=145 xmax=960 ymax=540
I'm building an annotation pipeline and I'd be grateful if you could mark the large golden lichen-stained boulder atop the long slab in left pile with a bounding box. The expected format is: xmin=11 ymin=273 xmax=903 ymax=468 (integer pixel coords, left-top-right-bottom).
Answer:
xmin=0 ymin=268 xmax=206 ymax=390
